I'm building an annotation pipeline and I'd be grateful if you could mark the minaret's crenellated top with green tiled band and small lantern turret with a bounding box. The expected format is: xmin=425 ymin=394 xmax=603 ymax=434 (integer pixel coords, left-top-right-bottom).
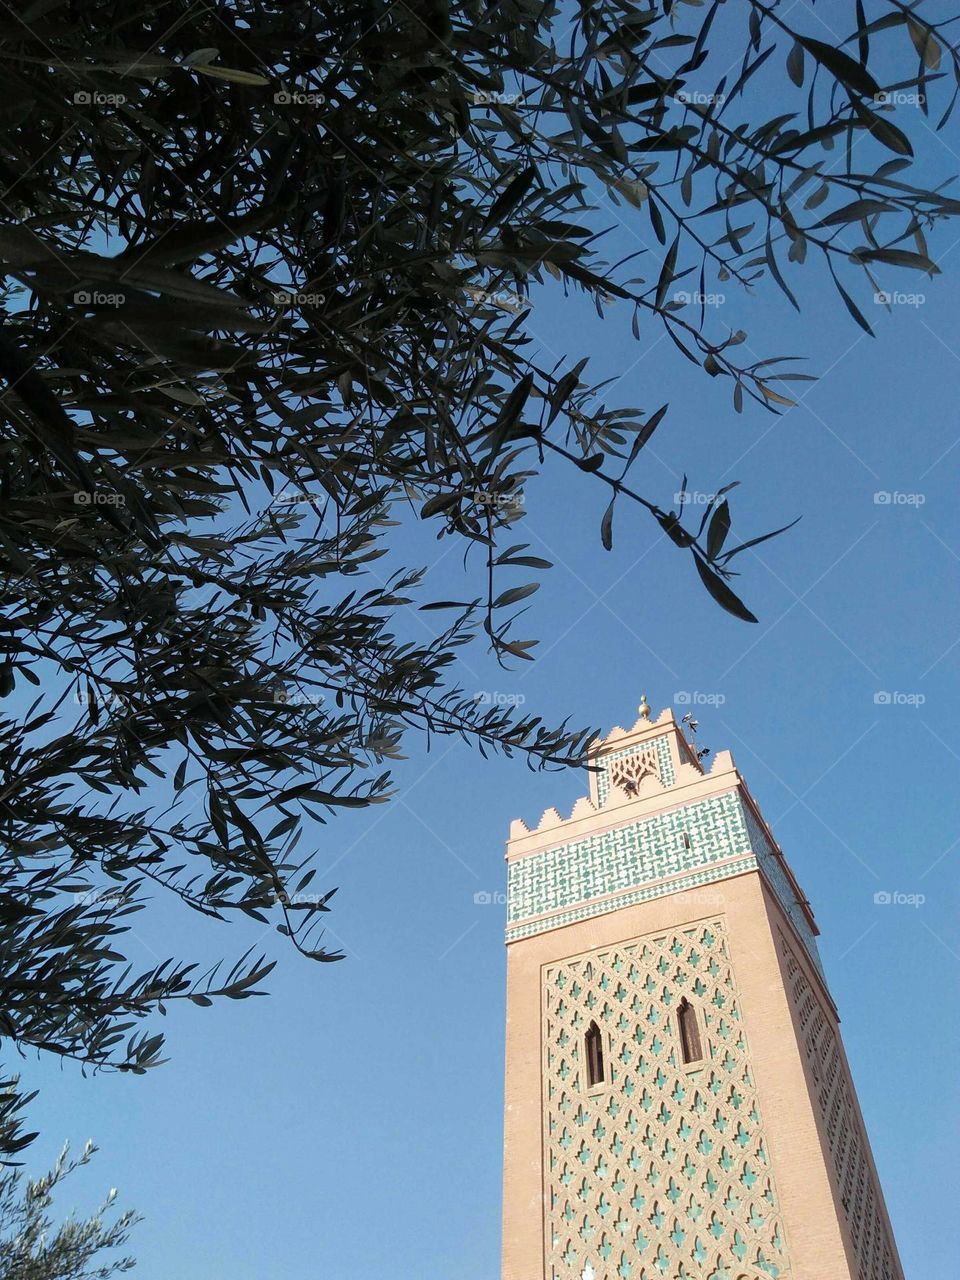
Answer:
xmin=507 ymin=707 xmax=819 ymax=964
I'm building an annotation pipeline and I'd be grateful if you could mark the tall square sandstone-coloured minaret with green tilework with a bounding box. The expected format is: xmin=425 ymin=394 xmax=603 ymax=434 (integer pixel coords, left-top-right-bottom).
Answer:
xmin=503 ymin=699 xmax=902 ymax=1280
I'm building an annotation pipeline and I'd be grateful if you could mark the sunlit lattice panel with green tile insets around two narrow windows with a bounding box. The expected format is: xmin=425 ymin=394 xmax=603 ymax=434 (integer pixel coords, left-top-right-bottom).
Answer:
xmin=543 ymin=919 xmax=791 ymax=1280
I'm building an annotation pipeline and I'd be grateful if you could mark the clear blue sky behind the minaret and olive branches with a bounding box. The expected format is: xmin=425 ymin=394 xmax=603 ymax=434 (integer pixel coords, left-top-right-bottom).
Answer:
xmin=23 ymin=20 xmax=960 ymax=1280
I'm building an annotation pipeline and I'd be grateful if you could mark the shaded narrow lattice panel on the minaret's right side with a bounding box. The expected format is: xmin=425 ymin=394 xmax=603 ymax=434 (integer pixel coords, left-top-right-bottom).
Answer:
xmin=780 ymin=936 xmax=902 ymax=1280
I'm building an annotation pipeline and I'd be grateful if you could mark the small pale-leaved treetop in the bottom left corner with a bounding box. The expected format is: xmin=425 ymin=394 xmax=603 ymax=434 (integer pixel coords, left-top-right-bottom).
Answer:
xmin=0 ymin=1142 xmax=140 ymax=1280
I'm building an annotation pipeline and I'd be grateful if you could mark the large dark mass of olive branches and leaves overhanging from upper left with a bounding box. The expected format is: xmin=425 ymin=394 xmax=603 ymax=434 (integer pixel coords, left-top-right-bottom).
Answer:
xmin=0 ymin=0 xmax=960 ymax=1152
